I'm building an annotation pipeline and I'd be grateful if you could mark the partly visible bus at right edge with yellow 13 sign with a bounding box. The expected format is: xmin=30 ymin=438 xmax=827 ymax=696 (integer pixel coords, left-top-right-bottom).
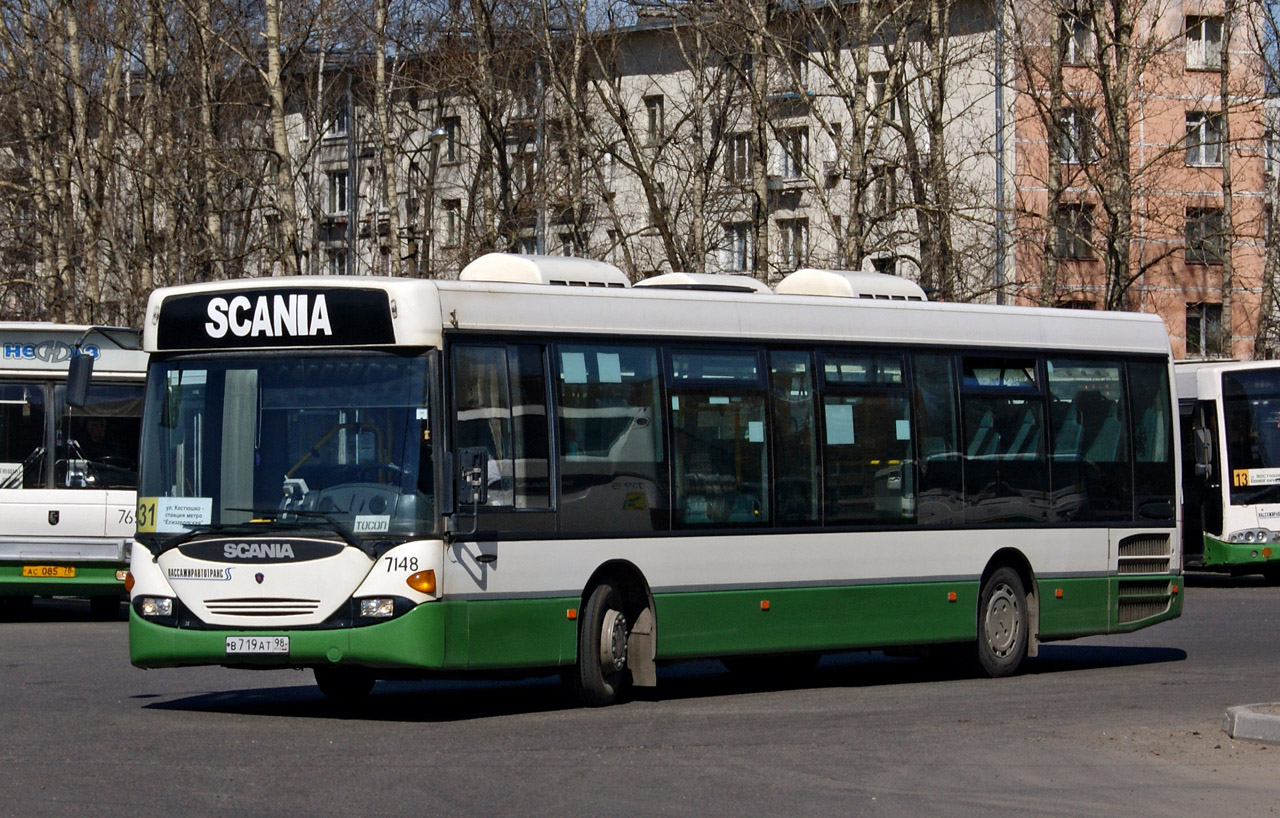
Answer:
xmin=1176 ymin=361 xmax=1280 ymax=582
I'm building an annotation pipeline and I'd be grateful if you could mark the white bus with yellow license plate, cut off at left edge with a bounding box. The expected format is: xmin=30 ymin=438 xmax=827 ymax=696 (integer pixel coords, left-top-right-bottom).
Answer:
xmin=0 ymin=323 xmax=146 ymax=618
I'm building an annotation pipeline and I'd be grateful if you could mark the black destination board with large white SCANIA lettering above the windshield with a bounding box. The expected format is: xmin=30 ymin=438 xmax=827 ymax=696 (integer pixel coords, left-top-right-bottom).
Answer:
xmin=157 ymin=287 xmax=396 ymax=349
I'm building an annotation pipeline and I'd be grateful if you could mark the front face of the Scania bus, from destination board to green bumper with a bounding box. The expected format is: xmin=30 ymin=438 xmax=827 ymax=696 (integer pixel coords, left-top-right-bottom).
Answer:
xmin=129 ymin=287 xmax=443 ymax=691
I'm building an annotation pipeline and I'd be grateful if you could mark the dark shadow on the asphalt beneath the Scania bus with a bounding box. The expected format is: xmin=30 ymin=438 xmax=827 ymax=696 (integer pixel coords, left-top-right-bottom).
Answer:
xmin=142 ymin=644 xmax=1187 ymax=722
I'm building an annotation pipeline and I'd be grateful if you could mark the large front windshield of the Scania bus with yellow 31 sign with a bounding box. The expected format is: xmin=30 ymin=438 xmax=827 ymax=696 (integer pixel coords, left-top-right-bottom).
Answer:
xmin=138 ymin=353 xmax=434 ymax=538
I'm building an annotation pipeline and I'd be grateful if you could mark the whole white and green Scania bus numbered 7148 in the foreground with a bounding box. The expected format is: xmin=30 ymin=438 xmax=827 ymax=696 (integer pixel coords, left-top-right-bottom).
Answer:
xmin=129 ymin=253 xmax=1181 ymax=704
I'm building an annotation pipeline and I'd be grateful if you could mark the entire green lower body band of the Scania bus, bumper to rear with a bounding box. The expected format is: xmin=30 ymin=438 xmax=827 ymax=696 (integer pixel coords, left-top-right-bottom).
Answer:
xmin=129 ymin=575 xmax=1181 ymax=672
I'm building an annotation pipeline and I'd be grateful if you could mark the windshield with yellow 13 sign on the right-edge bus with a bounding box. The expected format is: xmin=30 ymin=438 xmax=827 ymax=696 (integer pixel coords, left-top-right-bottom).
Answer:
xmin=1222 ymin=369 xmax=1280 ymax=506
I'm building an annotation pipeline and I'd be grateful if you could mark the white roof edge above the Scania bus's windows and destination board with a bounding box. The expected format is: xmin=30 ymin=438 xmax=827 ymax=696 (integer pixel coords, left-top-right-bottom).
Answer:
xmin=145 ymin=277 xmax=1169 ymax=355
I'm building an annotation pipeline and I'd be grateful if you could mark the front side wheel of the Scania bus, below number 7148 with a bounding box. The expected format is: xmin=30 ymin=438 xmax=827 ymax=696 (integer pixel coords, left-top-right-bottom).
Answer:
xmin=570 ymin=580 xmax=631 ymax=707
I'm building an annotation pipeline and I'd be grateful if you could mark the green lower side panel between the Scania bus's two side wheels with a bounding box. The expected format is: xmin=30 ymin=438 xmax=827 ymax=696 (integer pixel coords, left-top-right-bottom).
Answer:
xmin=654 ymin=580 xmax=978 ymax=659
